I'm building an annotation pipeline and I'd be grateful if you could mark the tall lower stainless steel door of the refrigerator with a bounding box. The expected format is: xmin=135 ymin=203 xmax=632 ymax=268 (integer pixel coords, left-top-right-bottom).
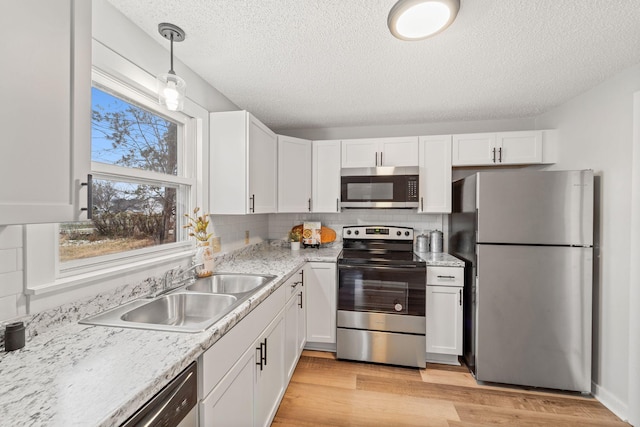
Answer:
xmin=476 ymin=245 xmax=593 ymax=392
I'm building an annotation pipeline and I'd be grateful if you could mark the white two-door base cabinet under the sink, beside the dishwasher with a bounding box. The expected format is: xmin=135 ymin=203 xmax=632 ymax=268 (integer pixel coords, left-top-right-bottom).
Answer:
xmin=199 ymin=284 xmax=287 ymax=426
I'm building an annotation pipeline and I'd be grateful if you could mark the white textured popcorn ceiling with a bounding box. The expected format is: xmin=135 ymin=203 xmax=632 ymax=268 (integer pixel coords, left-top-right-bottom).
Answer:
xmin=109 ymin=0 xmax=640 ymax=130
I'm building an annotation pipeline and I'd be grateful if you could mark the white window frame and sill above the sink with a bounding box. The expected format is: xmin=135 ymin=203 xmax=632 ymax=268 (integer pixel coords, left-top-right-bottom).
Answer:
xmin=23 ymin=55 xmax=209 ymax=298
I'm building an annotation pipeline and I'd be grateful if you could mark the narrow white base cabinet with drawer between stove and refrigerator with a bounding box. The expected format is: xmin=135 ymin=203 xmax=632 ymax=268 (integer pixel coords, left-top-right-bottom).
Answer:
xmin=426 ymin=267 xmax=464 ymax=365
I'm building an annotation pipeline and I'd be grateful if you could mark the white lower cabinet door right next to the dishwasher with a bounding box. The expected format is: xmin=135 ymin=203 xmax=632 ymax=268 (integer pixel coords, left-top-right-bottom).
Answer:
xmin=200 ymin=347 xmax=256 ymax=427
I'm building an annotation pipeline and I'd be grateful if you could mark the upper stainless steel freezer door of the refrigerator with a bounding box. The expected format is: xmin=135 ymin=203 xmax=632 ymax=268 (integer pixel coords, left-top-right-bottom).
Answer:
xmin=477 ymin=171 xmax=593 ymax=246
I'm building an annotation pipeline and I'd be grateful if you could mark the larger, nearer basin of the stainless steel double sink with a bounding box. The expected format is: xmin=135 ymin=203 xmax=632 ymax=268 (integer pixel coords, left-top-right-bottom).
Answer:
xmin=120 ymin=292 xmax=238 ymax=327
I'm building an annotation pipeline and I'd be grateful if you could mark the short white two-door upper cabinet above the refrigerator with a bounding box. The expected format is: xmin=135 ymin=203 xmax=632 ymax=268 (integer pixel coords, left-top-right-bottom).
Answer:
xmin=452 ymin=131 xmax=553 ymax=166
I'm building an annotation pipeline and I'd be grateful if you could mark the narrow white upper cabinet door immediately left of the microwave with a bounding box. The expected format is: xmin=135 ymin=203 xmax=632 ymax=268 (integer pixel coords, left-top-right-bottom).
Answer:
xmin=311 ymin=141 xmax=340 ymax=213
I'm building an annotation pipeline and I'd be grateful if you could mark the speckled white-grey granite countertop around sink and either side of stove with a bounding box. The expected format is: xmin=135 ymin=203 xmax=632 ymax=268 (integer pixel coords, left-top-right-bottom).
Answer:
xmin=0 ymin=244 xmax=464 ymax=426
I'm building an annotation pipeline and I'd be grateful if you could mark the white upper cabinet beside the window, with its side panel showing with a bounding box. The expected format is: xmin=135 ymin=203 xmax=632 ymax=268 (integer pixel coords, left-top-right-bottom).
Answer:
xmin=209 ymin=111 xmax=278 ymax=214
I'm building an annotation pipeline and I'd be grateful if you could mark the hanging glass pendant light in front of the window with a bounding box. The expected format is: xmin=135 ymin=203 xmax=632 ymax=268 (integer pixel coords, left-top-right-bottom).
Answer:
xmin=157 ymin=22 xmax=187 ymax=111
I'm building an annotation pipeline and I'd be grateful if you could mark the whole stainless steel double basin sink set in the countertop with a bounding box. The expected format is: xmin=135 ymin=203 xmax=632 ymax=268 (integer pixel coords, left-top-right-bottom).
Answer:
xmin=79 ymin=273 xmax=276 ymax=332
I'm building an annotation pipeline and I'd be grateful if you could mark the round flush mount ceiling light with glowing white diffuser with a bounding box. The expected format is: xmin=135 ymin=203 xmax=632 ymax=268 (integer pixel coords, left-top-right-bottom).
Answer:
xmin=387 ymin=0 xmax=460 ymax=40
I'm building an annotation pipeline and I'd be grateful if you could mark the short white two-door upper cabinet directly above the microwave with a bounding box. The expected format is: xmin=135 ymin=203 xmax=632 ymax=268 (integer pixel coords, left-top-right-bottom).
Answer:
xmin=342 ymin=136 xmax=418 ymax=168
